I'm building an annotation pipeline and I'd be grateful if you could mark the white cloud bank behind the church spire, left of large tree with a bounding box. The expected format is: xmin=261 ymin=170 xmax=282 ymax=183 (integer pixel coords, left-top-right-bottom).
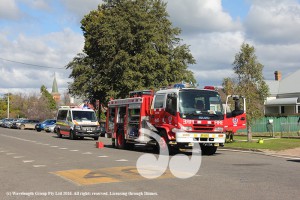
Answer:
xmin=0 ymin=29 xmax=84 ymax=90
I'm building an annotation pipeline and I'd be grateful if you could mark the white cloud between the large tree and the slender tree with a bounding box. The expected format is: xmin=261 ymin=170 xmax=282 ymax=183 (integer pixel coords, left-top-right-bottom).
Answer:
xmin=167 ymin=0 xmax=245 ymax=85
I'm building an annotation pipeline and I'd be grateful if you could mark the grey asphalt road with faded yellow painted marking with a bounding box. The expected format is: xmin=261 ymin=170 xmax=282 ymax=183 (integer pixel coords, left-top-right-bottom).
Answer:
xmin=0 ymin=128 xmax=300 ymax=200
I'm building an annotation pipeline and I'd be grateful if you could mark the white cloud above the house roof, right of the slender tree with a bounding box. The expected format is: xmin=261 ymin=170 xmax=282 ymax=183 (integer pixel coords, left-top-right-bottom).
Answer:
xmin=244 ymin=0 xmax=300 ymax=80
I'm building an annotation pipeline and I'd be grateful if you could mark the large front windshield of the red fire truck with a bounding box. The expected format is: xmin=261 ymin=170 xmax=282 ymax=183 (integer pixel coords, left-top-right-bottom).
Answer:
xmin=179 ymin=90 xmax=223 ymax=120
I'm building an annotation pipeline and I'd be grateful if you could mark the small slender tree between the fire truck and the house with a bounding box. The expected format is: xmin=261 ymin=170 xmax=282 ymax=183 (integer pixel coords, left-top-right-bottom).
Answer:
xmin=222 ymin=43 xmax=269 ymax=141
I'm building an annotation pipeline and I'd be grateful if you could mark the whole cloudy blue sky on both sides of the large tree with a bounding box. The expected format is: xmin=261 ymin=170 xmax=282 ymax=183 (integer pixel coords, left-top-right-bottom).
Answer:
xmin=0 ymin=0 xmax=300 ymax=94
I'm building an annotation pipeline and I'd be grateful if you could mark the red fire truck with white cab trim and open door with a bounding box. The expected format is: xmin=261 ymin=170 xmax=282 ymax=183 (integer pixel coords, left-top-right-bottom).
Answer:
xmin=106 ymin=85 xmax=246 ymax=155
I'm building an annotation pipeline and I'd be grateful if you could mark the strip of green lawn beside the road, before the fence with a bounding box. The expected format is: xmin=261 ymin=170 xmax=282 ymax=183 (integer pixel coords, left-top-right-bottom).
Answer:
xmin=225 ymin=136 xmax=300 ymax=151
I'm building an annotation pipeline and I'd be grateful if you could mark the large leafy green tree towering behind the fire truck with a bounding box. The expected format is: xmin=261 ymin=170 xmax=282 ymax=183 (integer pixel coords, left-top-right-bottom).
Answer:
xmin=67 ymin=0 xmax=196 ymax=103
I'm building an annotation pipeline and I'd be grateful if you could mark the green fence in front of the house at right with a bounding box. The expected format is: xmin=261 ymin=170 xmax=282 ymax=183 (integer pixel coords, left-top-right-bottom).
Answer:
xmin=238 ymin=116 xmax=300 ymax=136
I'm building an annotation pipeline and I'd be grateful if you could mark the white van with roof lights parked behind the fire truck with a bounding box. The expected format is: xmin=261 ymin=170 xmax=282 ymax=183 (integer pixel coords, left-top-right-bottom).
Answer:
xmin=56 ymin=106 xmax=101 ymax=140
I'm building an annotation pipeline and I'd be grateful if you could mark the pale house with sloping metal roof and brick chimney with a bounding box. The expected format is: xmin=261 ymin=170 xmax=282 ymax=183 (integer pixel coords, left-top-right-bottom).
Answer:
xmin=265 ymin=70 xmax=300 ymax=115
